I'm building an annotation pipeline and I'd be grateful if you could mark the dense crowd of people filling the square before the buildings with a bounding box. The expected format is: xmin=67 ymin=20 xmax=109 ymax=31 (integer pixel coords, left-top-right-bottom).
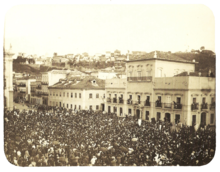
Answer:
xmin=4 ymin=107 xmax=215 ymax=167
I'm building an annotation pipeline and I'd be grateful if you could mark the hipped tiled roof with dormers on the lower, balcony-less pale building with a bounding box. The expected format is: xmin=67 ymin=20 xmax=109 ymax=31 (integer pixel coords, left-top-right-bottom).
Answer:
xmin=48 ymin=76 xmax=105 ymax=90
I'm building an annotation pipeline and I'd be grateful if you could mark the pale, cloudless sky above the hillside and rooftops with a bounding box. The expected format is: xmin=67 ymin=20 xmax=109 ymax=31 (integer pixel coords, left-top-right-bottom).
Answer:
xmin=3 ymin=3 xmax=217 ymax=57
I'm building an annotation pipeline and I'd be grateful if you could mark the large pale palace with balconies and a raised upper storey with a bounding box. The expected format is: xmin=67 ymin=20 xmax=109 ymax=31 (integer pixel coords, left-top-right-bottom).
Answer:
xmin=106 ymin=53 xmax=215 ymax=125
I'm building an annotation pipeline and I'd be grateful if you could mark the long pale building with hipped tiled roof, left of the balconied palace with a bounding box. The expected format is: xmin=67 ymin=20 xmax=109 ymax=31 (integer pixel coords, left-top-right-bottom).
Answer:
xmin=48 ymin=76 xmax=105 ymax=110
